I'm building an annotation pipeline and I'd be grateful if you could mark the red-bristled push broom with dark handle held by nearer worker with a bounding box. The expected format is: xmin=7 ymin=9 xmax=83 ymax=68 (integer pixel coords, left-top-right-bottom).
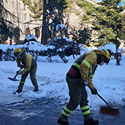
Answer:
xmin=86 ymin=84 xmax=120 ymax=115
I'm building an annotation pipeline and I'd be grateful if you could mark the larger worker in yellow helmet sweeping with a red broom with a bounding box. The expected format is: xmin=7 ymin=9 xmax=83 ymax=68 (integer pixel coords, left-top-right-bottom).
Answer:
xmin=57 ymin=49 xmax=110 ymax=125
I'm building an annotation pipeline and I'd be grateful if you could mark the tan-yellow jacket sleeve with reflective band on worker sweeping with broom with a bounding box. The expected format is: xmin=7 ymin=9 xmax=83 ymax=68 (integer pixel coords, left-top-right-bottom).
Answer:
xmin=80 ymin=52 xmax=97 ymax=88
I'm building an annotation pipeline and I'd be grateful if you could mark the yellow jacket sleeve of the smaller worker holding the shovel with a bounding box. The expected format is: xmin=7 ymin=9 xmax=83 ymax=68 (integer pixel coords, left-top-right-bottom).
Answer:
xmin=22 ymin=53 xmax=33 ymax=74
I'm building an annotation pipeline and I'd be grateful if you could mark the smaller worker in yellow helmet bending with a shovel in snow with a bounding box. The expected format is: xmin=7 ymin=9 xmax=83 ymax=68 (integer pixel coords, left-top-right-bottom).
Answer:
xmin=14 ymin=48 xmax=39 ymax=94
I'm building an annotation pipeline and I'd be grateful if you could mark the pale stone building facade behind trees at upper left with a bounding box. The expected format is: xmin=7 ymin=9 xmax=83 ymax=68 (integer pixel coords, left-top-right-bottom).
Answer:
xmin=2 ymin=0 xmax=42 ymax=42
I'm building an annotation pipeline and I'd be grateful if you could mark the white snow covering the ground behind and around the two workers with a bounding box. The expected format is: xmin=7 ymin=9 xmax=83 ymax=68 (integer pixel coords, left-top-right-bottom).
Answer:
xmin=0 ymin=43 xmax=125 ymax=110
